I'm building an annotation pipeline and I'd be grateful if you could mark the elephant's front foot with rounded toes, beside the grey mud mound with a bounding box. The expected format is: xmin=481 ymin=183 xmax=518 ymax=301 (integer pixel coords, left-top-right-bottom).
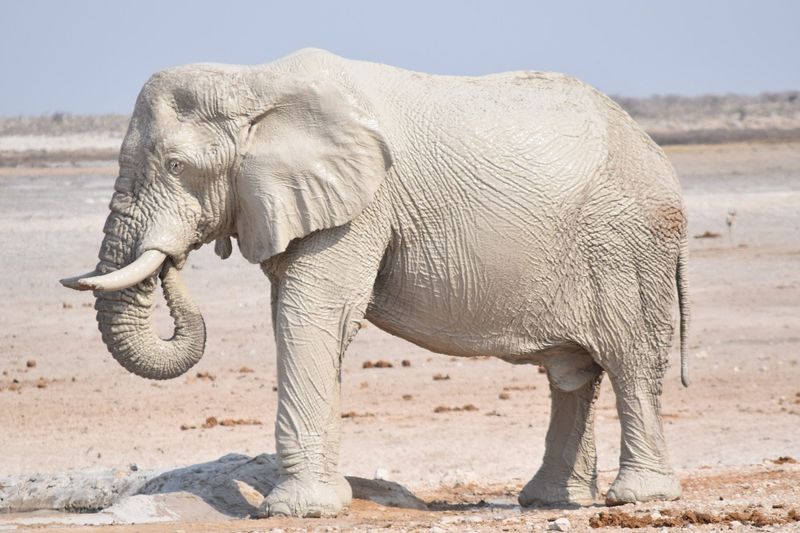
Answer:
xmin=253 ymin=475 xmax=352 ymax=518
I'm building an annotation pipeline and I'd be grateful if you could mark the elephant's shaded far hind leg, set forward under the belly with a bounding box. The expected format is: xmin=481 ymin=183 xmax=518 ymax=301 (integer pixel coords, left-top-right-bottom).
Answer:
xmin=519 ymin=352 xmax=603 ymax=506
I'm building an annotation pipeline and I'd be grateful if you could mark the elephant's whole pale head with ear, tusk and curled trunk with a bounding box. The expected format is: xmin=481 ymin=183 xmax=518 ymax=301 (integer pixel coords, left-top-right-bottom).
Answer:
xmin=62 ymin=51 xmax=391 ymax=379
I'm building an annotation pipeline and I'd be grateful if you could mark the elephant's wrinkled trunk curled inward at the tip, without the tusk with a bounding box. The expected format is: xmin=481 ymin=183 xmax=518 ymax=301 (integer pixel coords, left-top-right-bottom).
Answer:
xmin=95 ymin=202 xmax=206 ymax=379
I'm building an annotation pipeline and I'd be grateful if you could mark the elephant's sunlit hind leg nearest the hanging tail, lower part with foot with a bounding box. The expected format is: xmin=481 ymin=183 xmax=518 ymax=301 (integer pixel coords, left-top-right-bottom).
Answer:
xmin=606 ymin=358 xmax=681 ymax=505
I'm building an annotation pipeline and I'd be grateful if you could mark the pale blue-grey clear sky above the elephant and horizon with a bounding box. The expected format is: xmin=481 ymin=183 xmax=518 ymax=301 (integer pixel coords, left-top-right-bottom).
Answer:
xmin=0 ymin=0 xmax=800 ymax=116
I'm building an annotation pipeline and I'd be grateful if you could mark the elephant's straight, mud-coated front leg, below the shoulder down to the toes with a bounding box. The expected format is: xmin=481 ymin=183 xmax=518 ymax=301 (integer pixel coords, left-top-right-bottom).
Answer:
xmin=260 ymin=296 xmax=360 ymax=517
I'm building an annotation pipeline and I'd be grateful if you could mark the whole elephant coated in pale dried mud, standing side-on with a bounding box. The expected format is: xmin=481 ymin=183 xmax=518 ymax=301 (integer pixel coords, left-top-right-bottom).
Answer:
xmin=62 ymin=49 xmax=689 ymax=517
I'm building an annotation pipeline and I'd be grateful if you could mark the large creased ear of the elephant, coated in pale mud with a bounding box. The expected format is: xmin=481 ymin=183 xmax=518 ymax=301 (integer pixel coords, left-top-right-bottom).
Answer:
xmin=235 ymin=79 xmax=392 ymax=263
